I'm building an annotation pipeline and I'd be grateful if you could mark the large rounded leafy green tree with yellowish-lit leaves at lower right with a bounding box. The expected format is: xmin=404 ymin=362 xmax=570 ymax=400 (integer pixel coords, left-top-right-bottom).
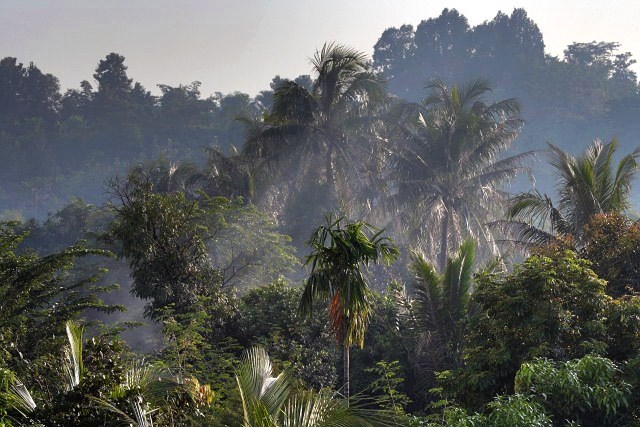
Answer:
xmin=439 ymin=249 xmax=609 ymax=408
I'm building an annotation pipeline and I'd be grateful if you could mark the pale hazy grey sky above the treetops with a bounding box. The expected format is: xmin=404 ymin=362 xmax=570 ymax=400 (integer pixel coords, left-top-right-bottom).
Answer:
xmin=0 ymin=0 xmax=640 ymax=96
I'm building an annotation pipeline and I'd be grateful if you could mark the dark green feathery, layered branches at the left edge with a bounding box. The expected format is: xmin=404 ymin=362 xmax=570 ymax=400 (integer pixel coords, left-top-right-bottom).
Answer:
xmin=0 ymin=223 xmax=122 ymax=364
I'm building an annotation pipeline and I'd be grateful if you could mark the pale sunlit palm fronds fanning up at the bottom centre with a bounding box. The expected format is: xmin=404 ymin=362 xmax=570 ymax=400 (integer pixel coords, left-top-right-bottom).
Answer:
xmin=236 ymin=347 xmax=395 ymax=427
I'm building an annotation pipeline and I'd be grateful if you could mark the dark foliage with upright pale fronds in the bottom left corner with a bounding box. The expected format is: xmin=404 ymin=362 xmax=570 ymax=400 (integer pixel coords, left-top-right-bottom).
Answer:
xmin=0 ymin=322 xmax=213 ymax=426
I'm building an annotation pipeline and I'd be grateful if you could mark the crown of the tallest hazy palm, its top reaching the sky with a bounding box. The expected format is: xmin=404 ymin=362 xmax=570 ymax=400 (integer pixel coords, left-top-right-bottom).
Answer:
xmin=243 ymin=43 xmax=385 ymax=214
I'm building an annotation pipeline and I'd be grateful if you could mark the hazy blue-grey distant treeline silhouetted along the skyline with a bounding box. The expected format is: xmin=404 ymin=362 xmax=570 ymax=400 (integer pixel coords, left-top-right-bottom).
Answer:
xmin=0 ymin=9 xmax=640 ymax=217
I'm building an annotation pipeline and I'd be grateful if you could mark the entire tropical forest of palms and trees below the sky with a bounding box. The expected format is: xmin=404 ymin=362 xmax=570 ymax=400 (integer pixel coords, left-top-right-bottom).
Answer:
xmin=0 ymin=9 xmax=640 ymax=427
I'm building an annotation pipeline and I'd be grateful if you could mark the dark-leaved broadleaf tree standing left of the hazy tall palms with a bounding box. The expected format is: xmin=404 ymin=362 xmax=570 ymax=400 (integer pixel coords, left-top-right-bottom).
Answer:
xmin=110 ymin=173 xmax=222 ymax=318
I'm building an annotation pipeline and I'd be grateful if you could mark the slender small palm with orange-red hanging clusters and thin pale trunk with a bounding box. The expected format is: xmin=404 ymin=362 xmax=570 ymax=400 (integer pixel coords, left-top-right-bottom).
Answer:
xmin=299 ymin=214 xmax=399 ymax=398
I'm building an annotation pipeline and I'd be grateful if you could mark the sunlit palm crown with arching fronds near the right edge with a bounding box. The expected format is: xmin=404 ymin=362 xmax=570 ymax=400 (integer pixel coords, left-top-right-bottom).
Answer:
xmin=499 ymin=140 xmax=640 ymax=244
